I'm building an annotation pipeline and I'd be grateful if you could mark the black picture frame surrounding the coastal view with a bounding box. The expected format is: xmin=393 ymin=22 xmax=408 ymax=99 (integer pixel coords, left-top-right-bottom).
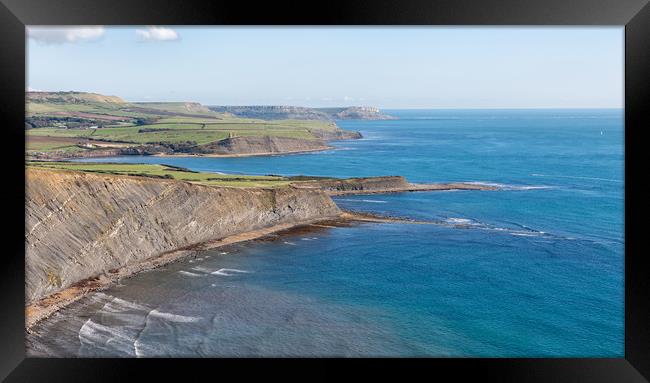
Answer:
xmin=0 ymin=0 xmax=650 ymax=382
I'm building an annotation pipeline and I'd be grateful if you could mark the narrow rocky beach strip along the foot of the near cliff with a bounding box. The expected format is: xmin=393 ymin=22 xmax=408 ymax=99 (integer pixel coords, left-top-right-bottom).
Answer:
xmin=25 ymin=211 xmax=410 ymax=332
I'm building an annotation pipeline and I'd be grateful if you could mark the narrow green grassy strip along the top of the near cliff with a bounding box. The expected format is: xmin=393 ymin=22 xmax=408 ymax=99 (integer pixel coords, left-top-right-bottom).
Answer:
xmin=27 ymin=161 xmax=292 ymax=187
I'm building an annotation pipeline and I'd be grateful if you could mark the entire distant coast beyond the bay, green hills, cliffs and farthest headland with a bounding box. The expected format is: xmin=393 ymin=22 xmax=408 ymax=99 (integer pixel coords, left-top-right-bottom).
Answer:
xmin=25 ymin=92 xmax=393 ymax=160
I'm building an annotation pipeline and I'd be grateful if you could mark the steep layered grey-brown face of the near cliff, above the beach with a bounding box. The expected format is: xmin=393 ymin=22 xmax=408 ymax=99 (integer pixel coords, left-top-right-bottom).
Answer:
xmin=25 ymin=169 xmax=340 ymax=303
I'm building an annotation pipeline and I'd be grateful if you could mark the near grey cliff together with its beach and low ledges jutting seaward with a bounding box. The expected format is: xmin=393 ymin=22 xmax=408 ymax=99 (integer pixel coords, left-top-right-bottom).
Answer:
xmin=25 ymin=168 xmax=495 ymax=329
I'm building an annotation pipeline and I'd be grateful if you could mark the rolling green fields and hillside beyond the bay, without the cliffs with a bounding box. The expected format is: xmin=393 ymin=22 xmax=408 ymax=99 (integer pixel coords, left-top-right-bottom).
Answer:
xmin=25 ymin=92 xmax=354 ymax=155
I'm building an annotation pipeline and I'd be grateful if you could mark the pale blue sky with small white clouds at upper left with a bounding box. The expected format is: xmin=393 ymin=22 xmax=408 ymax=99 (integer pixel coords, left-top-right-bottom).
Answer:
xmin=26 ymin=26 xmax=624 ymax=109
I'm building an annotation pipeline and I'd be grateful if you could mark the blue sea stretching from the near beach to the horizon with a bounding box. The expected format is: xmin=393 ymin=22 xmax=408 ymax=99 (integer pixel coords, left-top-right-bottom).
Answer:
xmin=28 ymin=109 xmax=624 ymax=357
